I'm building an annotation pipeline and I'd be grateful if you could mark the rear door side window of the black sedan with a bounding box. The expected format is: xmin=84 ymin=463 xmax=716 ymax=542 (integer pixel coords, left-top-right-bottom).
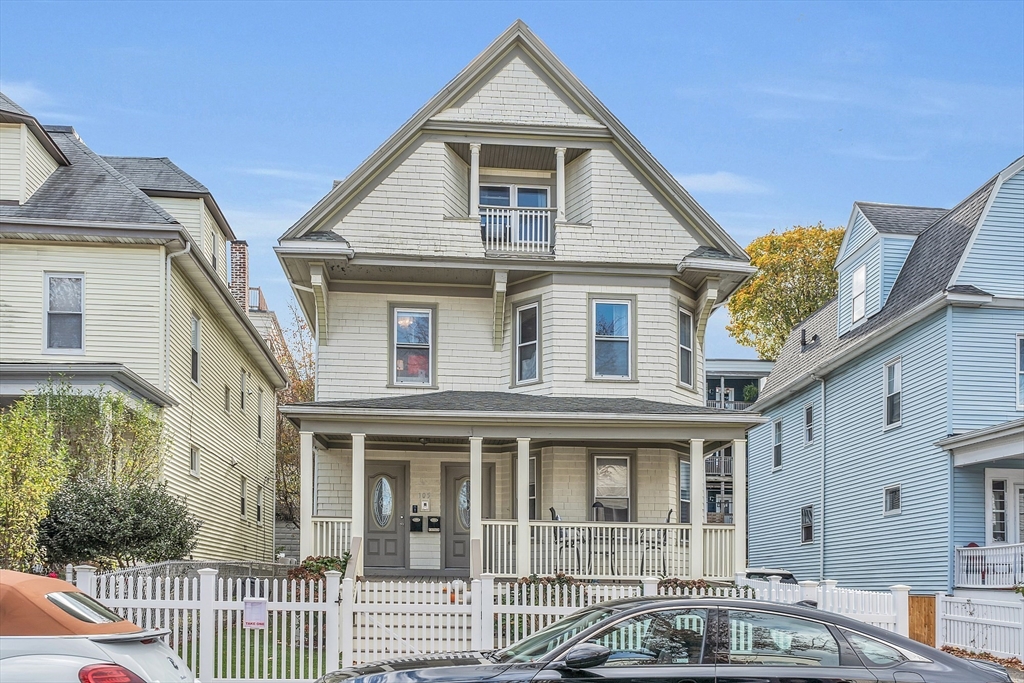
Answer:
xmin=729 ymin=609 xmax=839 ymax=667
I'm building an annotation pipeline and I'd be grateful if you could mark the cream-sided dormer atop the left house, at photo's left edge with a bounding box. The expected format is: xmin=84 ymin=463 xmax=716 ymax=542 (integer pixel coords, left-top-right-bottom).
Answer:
xmin=0 ymin=93 xmax=69 ymax=205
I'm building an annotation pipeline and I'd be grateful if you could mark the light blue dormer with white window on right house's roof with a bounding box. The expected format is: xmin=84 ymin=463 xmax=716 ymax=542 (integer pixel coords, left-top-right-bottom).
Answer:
xmin=836 ymin=202 xmax=946 ymax=335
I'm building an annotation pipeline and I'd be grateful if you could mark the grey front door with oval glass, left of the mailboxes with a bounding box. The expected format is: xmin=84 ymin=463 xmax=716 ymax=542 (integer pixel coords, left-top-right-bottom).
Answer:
xmin=365 ymin=460 xmax=409 ymax=567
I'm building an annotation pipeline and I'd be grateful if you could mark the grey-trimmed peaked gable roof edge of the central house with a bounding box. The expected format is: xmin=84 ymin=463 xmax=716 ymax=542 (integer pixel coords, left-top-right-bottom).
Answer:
xmin=281 ymin=20 xmax=749 ymax=262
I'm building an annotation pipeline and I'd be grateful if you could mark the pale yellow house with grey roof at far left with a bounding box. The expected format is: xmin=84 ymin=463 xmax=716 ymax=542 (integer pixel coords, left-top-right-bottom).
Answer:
xmin=0 ymin=95 xmax=285 ymax=560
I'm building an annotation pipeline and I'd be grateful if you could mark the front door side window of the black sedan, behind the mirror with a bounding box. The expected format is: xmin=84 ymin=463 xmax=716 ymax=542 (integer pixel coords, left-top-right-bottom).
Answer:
xmin=587 ymin=609 xmax=708 ymax=667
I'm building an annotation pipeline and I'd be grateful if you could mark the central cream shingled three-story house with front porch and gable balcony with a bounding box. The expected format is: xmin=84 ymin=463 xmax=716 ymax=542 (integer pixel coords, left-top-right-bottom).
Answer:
xmin=276 ymin=23 xmax=760 ymax=579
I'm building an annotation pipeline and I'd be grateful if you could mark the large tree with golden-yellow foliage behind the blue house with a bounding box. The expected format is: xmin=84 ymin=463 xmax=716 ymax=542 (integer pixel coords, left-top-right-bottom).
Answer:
xmin=725 ymin=223 xmax=845 ymax=360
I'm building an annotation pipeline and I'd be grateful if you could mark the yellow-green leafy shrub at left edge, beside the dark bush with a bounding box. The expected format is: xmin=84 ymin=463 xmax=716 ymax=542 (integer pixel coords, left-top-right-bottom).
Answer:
xmin=0 ymin=400 xmax=68 ymax=569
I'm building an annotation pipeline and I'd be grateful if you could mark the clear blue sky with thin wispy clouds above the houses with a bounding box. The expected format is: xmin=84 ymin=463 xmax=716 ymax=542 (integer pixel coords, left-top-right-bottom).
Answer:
xmin=0 ymin=0 xmax=1024 ymax=357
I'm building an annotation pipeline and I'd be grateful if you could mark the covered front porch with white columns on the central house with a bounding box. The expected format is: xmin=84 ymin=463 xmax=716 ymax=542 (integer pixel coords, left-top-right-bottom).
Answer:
xmin=285 ymin=392 xmax=758 ymax=581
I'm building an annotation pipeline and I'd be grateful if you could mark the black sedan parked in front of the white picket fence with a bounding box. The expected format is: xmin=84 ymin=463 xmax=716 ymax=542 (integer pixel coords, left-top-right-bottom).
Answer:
xmin=321 ymin=598 xmax=1010 ymax=683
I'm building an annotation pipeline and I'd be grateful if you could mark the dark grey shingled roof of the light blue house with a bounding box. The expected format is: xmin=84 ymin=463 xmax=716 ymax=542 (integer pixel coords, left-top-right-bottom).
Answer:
xmin=755 ymin=176 xmax=998 ymax=410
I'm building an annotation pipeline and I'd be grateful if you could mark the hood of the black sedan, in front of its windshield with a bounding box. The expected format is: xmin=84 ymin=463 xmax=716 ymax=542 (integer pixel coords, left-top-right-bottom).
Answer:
xmin=318 ymin=651 xmax=536 ymax=683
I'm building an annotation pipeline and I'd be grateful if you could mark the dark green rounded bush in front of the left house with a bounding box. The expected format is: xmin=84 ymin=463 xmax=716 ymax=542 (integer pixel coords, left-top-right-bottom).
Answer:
xmin=39 ymin=475 xmax=200 ymax=567
